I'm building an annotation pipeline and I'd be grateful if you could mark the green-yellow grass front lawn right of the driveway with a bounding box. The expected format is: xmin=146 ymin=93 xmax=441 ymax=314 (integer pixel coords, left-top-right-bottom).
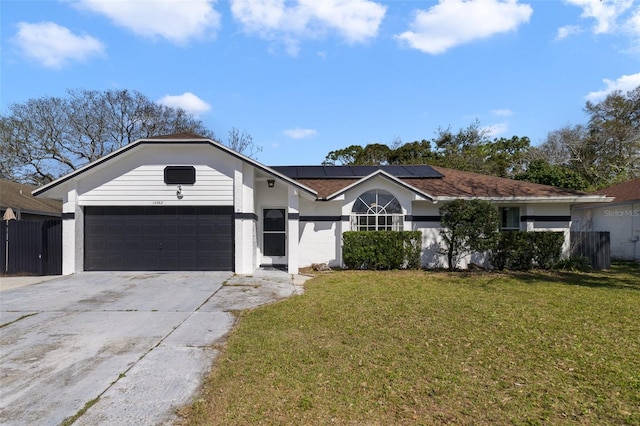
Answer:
xmin=182 ymin=264 xmax=640 ymax=425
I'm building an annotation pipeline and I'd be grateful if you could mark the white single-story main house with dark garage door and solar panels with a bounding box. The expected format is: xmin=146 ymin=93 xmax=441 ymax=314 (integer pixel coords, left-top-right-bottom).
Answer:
xmin=34 ymin=134 xmax=607 ymax=274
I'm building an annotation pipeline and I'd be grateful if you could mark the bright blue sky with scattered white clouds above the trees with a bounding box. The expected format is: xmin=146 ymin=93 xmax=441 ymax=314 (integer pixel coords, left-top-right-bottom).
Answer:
xmin=0 ymin=0 xmax=640 ymax=165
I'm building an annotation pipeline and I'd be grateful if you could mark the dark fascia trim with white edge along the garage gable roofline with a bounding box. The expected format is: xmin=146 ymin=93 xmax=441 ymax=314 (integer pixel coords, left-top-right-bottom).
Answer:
xmin=32 ymin=138 xmax=318 ymax=197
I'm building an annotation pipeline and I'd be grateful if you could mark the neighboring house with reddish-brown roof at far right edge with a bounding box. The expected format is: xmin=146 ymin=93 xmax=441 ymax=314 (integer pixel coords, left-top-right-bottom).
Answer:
xmin=572 ymin=178 xmax=640 ymax=260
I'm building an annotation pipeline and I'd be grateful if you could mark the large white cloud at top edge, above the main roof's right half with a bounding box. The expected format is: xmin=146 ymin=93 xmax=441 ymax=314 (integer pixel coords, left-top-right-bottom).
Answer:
xmin=396 ymin=0 xmax=533 ymax=55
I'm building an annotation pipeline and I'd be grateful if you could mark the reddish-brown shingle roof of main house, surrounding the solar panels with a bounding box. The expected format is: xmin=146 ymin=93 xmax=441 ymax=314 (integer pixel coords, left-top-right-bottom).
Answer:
xmin=282 ymin=166 xmax=610 ymax=202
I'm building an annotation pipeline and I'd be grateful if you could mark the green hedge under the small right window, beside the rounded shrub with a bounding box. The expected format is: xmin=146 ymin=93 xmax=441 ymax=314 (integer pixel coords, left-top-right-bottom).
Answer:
xmin=491 ymin=231 xmax=564 ymax=271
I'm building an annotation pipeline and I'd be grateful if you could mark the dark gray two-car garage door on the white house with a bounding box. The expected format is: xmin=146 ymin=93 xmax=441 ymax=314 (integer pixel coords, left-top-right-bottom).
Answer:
xmin=84 ymin=206 xmax=233 ymax=271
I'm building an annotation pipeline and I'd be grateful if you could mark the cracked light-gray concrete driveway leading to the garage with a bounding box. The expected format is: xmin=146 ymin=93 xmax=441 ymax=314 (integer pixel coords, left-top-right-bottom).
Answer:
xmin=0 ymin=271 xmax=302 ymax=425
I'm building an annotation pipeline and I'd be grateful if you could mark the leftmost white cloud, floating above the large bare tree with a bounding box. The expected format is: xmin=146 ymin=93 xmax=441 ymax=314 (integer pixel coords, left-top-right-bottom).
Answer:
xmin=13 ymin=22 xmax=105 ymax=68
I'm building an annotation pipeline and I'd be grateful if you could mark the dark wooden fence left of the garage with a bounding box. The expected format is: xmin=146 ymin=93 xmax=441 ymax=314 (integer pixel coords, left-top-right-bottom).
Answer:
xmin=0 ymin=219 xmax=62 ymax=275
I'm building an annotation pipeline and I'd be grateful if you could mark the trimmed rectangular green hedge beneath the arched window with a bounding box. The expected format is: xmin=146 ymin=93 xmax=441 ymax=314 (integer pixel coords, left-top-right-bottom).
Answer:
xmin=342 ymin=231 xmax=422 ymax=270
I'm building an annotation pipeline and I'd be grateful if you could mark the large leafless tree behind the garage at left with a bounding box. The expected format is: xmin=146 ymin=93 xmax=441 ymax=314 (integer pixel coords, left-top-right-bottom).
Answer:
xmin=0 ymin=90 xmax=218 ymax=184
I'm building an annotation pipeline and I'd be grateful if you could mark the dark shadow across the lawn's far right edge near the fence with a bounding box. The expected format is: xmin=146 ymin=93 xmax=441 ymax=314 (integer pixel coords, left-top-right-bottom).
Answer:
xmin=508 ymin=262 xmax=640 ymax=290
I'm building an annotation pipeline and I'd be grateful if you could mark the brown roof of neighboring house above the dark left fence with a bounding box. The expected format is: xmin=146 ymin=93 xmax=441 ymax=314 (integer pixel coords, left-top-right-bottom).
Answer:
xmin=0 ymin=179 xmax=62 ymax=216
